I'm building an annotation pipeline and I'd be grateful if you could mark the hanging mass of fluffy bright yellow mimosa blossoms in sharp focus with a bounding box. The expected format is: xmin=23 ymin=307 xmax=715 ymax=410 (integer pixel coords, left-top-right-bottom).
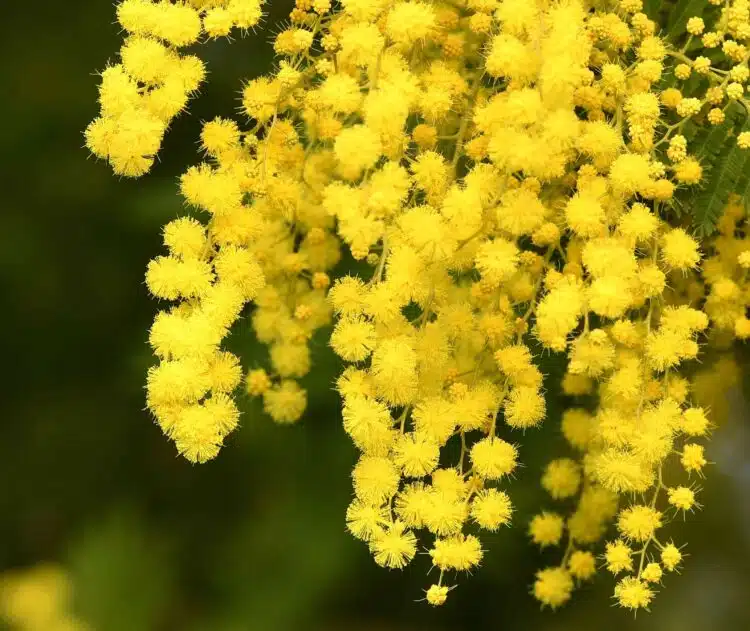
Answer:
xmin=86 ymin=0 xmax=750 ymax=610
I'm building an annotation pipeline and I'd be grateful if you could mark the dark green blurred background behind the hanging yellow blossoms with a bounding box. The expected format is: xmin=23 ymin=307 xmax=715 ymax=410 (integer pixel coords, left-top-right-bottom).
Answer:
xmin=0 ymin=0 xmax=750 ymax=631
